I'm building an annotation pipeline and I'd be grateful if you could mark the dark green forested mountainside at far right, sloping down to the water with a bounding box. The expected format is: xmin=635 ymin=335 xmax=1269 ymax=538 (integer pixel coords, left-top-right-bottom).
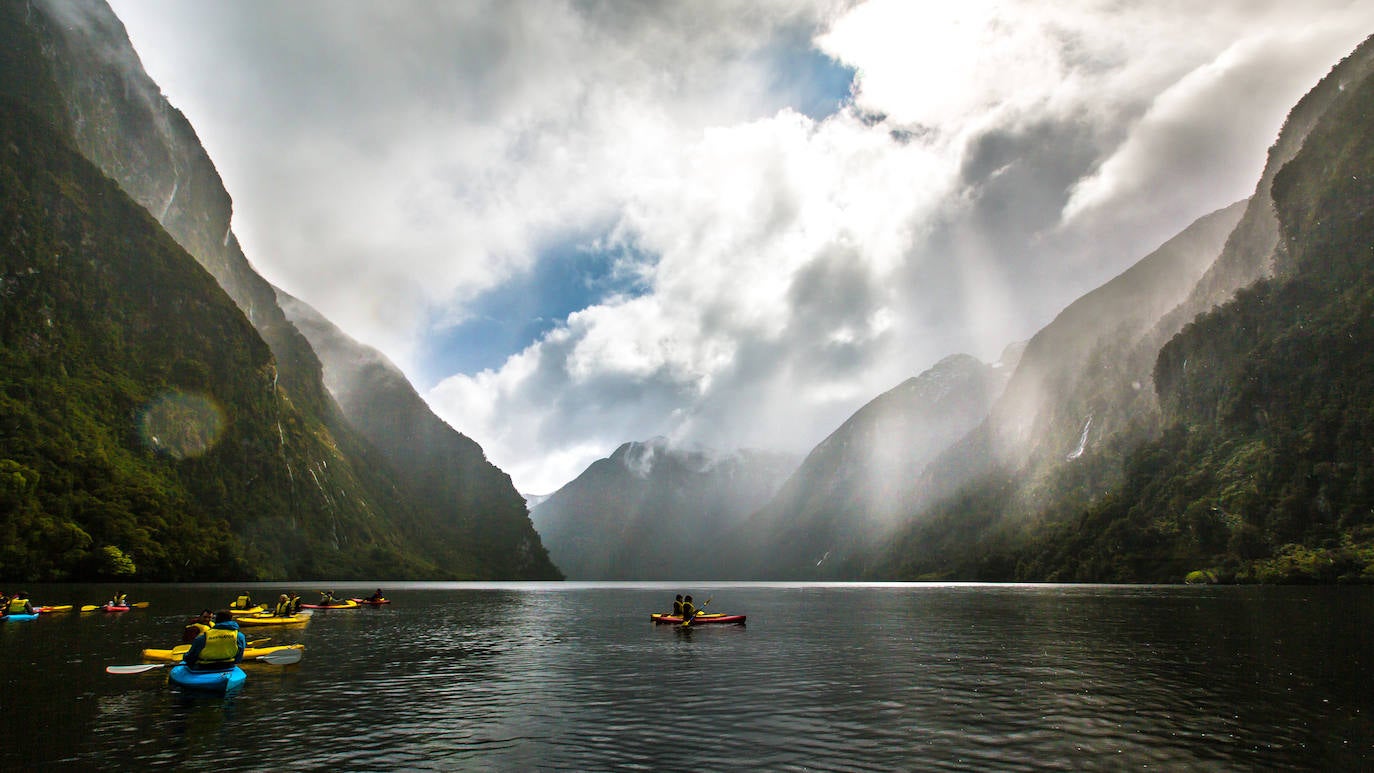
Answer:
xmin=872 ymin=33 xmax=1374 ymax=581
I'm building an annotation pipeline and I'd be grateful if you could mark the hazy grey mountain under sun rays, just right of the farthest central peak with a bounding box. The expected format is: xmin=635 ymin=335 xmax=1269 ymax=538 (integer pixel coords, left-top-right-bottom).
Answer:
xmin=716 ymin=346 xmax=1021 ymax=579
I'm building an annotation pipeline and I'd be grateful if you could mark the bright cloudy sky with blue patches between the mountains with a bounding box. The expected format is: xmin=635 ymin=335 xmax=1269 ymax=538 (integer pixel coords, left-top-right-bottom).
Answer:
xmin=101 ymin=0 xmax=1374 ymax=494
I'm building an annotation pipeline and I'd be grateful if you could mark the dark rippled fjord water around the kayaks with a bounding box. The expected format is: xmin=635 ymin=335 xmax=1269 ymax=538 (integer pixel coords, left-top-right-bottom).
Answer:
xmin=0 ymin=584 xmax=1374 ymax=770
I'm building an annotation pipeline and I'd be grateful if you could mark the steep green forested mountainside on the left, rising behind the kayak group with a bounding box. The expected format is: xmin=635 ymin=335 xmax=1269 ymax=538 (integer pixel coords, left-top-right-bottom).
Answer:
xmin=0 ymin=4 xmax=558 ymax=581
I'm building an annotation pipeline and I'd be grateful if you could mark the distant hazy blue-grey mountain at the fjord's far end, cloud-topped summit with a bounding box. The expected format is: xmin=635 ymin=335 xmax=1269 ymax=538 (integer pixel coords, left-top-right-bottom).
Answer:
xmin=532 ymin=438 xmax=796 ymax=579
